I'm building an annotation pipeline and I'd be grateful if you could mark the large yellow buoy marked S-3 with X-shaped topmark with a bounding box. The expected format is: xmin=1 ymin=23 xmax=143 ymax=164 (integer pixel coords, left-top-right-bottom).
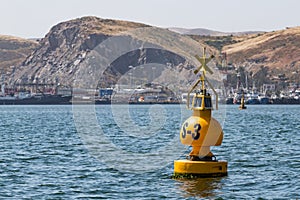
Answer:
xmin=174 ymin=49 xmax=227 ymax=177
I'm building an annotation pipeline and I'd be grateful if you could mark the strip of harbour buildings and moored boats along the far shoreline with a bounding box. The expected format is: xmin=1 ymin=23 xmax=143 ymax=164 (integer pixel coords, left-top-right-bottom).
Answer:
xmin=0 ymin=85 xmax=300 ymax=105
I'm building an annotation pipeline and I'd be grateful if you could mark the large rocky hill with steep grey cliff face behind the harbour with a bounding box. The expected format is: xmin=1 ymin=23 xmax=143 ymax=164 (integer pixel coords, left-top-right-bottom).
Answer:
xmin=11 ymin=17 xmax=217 ymax=91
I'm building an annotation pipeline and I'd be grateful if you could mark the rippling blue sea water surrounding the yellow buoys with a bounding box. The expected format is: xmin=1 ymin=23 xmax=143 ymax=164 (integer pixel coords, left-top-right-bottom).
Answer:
xmin=0 ymin=105 xmax=300 ymax=199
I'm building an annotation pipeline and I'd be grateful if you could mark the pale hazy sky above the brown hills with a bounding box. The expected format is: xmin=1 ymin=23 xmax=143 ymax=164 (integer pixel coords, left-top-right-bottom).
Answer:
xmin=0 ymin=0 xmax=300 ymax=38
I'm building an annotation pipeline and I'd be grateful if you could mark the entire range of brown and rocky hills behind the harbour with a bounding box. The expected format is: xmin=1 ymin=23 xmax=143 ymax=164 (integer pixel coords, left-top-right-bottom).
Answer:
xmin=0 ymin=17 xmax=300 ymax=92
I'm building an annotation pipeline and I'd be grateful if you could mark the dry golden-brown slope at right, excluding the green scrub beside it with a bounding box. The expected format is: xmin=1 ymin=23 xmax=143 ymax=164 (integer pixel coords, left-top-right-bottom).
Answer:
xmin=223 ymin=27 xmax=300 ymax=82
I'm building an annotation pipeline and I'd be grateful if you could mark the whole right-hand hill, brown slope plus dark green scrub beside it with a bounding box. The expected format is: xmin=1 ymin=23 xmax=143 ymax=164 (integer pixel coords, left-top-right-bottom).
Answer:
xmin=190 ymin=27 xmax=300 ymax=86
